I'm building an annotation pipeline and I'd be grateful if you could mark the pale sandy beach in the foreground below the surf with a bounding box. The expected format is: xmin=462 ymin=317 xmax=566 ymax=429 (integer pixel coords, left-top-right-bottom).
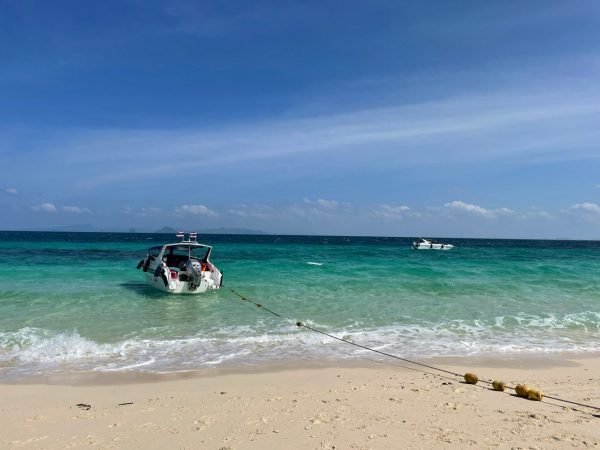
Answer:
xmin=0 ymin=357 xmax=600 ymax=449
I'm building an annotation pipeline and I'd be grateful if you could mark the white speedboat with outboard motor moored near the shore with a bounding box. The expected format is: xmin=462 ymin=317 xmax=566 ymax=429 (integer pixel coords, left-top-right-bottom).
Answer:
xmin=137 ymin=232 xmax=223 ymax=294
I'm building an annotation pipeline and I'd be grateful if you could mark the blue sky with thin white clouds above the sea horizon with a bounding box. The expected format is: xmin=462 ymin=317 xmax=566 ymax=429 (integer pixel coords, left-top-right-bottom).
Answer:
xmin=0 ymin=0 xmax=600 ymax=239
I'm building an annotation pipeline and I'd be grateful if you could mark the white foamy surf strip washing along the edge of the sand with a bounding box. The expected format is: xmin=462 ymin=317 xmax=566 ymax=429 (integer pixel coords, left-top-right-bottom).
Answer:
xmin=0 ymin=312 xmax=600 ymax=378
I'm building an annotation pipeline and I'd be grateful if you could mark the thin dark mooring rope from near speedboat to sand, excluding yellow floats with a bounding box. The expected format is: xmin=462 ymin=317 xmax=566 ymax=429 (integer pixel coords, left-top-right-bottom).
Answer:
xmin=223 ymin=286 xmax=600 ymax=418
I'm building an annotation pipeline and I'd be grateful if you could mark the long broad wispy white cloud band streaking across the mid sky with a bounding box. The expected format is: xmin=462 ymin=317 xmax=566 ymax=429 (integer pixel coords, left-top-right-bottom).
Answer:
xmin=19 ymin=85 xmax=600 ymax=188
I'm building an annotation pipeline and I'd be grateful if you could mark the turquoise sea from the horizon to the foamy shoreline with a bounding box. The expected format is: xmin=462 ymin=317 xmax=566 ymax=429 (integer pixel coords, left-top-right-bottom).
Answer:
xmin=0 ymin=232 xmax=600 ymax=379
